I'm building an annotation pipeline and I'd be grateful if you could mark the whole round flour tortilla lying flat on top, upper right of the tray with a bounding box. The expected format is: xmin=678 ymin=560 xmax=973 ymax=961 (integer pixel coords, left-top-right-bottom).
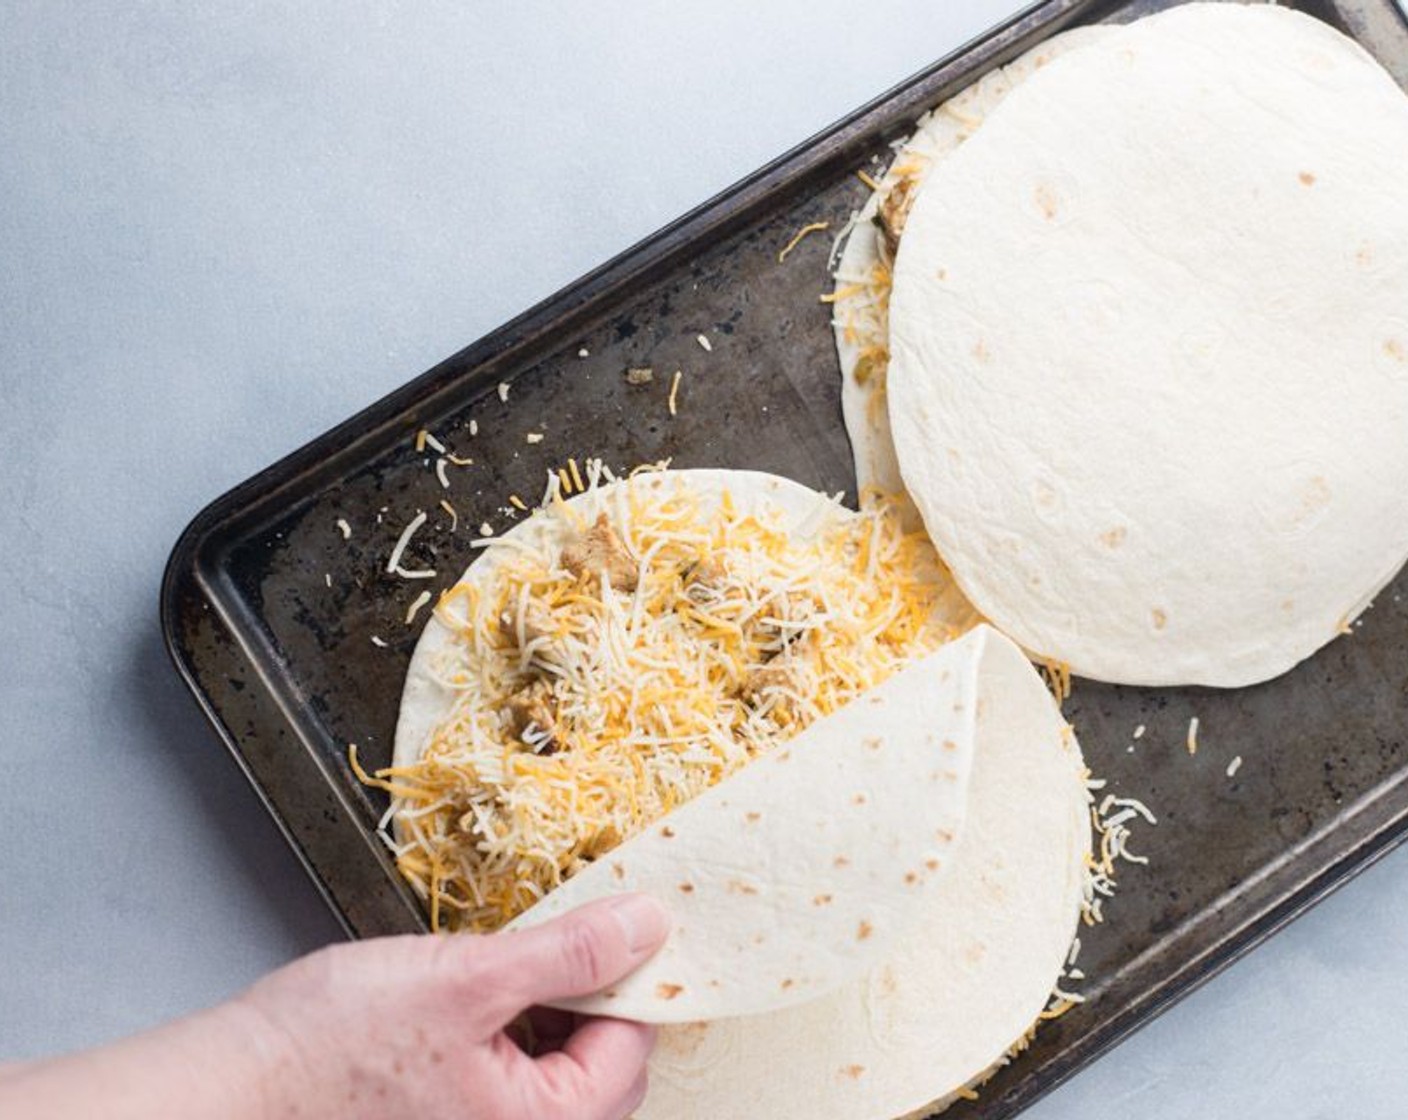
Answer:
xmin=888 ymin=4 xmax=1408 ymax=686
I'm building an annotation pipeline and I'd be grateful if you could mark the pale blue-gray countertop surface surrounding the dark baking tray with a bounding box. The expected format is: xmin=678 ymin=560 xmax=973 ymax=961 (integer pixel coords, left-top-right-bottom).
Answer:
xmin=0 ymin=0 xmax=1408 ymax=1120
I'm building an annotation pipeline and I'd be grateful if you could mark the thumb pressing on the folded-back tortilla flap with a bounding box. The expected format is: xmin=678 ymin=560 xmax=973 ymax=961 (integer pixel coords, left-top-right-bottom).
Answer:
xmin=480 ymin=895 xmax=670 ymax=1023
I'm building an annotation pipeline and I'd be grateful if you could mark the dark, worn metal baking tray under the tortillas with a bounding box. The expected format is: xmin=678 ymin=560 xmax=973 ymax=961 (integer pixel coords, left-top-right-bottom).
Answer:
xmin=162 ymin=0 xmax=1408 ymax=1120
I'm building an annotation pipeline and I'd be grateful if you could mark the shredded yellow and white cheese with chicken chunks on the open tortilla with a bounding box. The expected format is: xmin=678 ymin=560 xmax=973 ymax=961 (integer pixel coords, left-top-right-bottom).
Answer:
xmin=352 ymin=462 xmax=955 ymax=931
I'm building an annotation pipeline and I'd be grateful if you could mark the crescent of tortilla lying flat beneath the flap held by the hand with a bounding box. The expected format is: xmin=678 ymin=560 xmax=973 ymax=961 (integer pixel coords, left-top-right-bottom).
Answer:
xmin=636 ymin=627 xmax=1090 ymax=1120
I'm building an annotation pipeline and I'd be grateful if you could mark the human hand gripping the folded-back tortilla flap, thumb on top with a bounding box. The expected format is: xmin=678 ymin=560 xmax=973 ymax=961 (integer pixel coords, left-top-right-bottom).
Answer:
xmin=231 ymin=895 xmax=669 ymax=1120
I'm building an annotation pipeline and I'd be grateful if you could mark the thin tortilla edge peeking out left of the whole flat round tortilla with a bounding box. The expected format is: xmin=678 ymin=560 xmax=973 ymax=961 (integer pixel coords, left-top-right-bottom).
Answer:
xmin=834 ymin=24 xmax=1115 ymax=507
